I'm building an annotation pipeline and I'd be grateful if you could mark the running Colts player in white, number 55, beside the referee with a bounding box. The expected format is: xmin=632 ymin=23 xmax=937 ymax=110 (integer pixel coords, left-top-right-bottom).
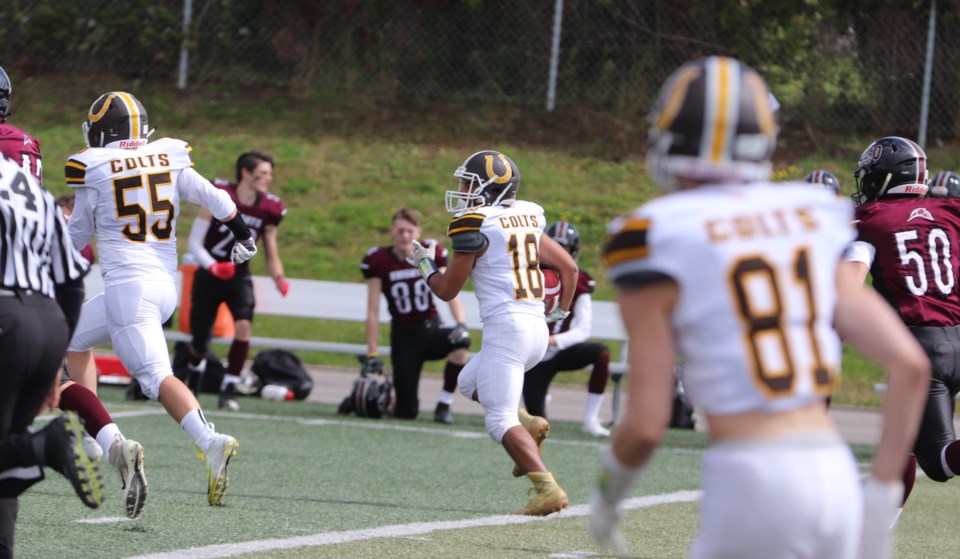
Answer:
xmin=65 ymin=91 xmax=256 ymax=506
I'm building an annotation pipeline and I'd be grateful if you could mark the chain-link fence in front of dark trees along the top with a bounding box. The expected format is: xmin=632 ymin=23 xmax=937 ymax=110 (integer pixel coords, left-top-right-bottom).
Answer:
xmin=0 ymin=0 xmax=960 ymax=147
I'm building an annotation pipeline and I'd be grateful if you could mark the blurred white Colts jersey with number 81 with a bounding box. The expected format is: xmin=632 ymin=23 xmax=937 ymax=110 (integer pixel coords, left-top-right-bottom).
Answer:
xmin=604 ymin=182 xmax=854 ymax=415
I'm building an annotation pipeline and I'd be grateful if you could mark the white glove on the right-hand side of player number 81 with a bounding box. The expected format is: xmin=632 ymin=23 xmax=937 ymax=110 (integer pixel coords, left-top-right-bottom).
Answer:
xmin=857 ymin=475 xmax=903 ymax=559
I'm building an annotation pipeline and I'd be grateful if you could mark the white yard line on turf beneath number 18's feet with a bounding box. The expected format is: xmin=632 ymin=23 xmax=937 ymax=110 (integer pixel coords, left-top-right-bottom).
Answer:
xmin=128 ymin=491 xmax=701 ymax=559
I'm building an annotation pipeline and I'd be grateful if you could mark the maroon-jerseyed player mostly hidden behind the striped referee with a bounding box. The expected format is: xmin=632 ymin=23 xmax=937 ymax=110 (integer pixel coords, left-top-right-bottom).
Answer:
xmin=0 ymin=68 xmax=147 ymax=518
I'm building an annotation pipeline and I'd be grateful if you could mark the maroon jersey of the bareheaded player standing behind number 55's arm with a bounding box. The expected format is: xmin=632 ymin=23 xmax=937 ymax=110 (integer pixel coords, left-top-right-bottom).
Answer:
xmin=203 ymin=179 xmax=287 ymax=276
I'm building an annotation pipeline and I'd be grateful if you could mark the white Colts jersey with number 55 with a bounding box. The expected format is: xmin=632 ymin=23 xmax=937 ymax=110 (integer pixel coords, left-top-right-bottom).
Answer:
xmin=65 ymin=138 xmax=236 ymax=285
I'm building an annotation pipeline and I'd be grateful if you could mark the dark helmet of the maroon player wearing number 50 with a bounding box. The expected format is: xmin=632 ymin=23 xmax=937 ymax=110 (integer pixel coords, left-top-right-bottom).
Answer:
xmin=853 ymin=136 xmax=928 ymax=205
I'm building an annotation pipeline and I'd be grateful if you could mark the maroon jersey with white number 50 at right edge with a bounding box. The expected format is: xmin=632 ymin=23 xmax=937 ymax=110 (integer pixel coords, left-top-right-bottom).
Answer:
xmin=856 ymin=198 xmax=960 ymax=326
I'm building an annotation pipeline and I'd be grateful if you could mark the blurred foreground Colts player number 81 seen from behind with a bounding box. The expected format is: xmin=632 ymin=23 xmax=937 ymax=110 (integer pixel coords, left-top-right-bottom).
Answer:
xmin=590 ymin=56 xmax=930 ymax=559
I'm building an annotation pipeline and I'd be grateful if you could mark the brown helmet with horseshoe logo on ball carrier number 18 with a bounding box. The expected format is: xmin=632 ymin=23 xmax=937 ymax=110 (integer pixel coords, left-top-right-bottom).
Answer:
xmin=445 ymin=150 xmax=520 ymax=212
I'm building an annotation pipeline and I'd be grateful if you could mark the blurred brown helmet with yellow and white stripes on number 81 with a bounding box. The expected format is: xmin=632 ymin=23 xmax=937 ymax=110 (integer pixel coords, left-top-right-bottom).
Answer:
xmin=647 ymin=56 xmax=778 ymax=190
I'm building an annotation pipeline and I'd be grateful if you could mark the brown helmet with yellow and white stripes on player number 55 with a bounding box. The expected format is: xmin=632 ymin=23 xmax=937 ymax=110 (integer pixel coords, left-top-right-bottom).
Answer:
xmin=82 ymin=91 xmax=153 ymax=149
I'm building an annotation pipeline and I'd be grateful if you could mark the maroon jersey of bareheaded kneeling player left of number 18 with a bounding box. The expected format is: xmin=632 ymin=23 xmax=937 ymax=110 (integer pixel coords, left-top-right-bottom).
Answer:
xmin=360 ymin=241 xmax=447 ymax=322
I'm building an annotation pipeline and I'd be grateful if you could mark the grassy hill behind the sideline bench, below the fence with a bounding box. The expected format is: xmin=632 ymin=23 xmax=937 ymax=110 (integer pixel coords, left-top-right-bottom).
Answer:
xmin=10 ymin=74 xmax=960 ymax=403
